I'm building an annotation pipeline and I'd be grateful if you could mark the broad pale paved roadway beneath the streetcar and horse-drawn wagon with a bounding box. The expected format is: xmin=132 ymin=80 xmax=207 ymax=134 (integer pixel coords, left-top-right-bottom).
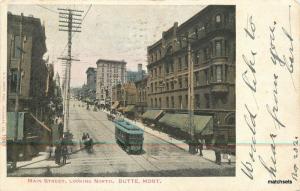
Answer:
xmin=8 ymin=101 xmax=235 ymax=176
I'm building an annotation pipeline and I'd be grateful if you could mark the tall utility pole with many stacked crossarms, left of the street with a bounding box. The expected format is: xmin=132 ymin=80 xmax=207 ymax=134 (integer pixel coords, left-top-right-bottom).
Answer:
xmin=58 ymin=8 xmax=83 ymax=131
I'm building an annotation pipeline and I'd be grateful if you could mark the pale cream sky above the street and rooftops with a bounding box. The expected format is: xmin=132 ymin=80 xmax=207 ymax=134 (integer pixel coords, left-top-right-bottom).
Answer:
xmin=8 ymin=4 xmax=204 ymax=87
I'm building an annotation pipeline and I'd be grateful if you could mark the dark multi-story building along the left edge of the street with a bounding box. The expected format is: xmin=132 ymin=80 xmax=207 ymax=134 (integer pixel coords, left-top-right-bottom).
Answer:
xmin=7 ymin=13 xmax=48 ymax=120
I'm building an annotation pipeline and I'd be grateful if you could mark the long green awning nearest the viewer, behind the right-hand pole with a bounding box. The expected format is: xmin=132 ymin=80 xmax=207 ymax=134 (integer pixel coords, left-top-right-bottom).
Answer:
xmin=159 ymin=113 xmax=213 ymax=135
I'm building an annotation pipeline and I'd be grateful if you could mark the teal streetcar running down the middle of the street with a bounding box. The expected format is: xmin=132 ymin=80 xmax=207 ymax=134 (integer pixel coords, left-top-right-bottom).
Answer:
xmin=114 ymin=119 xmax=144 ymax=154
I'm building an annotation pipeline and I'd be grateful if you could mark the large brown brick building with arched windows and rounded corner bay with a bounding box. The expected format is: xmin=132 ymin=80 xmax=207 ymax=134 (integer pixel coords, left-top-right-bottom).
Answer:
xmin=147 ymin=5 xmax=235 ymax=149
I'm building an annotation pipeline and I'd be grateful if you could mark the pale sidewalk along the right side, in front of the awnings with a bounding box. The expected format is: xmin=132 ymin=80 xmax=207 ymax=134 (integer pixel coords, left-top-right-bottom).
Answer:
xmin=103 ymin=111 xmax=236 ymax=163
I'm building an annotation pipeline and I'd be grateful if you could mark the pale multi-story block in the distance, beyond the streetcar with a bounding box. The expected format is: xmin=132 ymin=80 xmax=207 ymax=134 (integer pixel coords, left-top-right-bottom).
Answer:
xmin=96 ymin=59 xmax=126 ymax=104
